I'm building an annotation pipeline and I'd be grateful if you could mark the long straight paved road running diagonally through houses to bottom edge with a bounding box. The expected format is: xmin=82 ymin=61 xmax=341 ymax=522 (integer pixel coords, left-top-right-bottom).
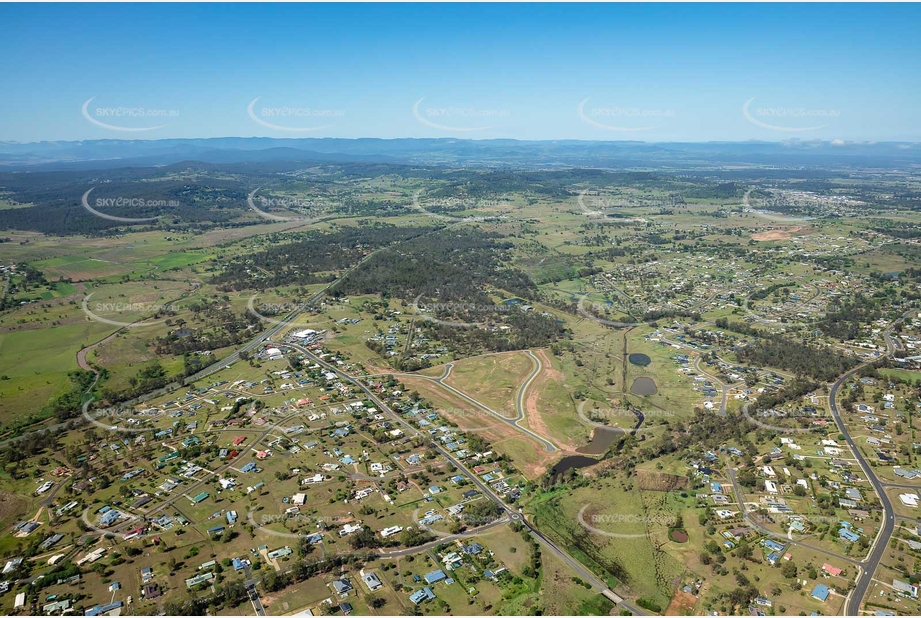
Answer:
xmin=276 ymin=343 xmax=647 ymax=616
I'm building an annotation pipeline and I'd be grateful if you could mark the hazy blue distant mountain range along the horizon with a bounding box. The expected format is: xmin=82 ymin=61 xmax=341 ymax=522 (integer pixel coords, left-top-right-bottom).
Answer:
xmin=0 ymin=137 xmax=921 ymax=171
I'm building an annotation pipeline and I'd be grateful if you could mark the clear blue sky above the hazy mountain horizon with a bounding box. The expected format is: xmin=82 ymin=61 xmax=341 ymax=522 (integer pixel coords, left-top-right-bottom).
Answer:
xmin=0 ymin=4 xmax=921 ymax=141
